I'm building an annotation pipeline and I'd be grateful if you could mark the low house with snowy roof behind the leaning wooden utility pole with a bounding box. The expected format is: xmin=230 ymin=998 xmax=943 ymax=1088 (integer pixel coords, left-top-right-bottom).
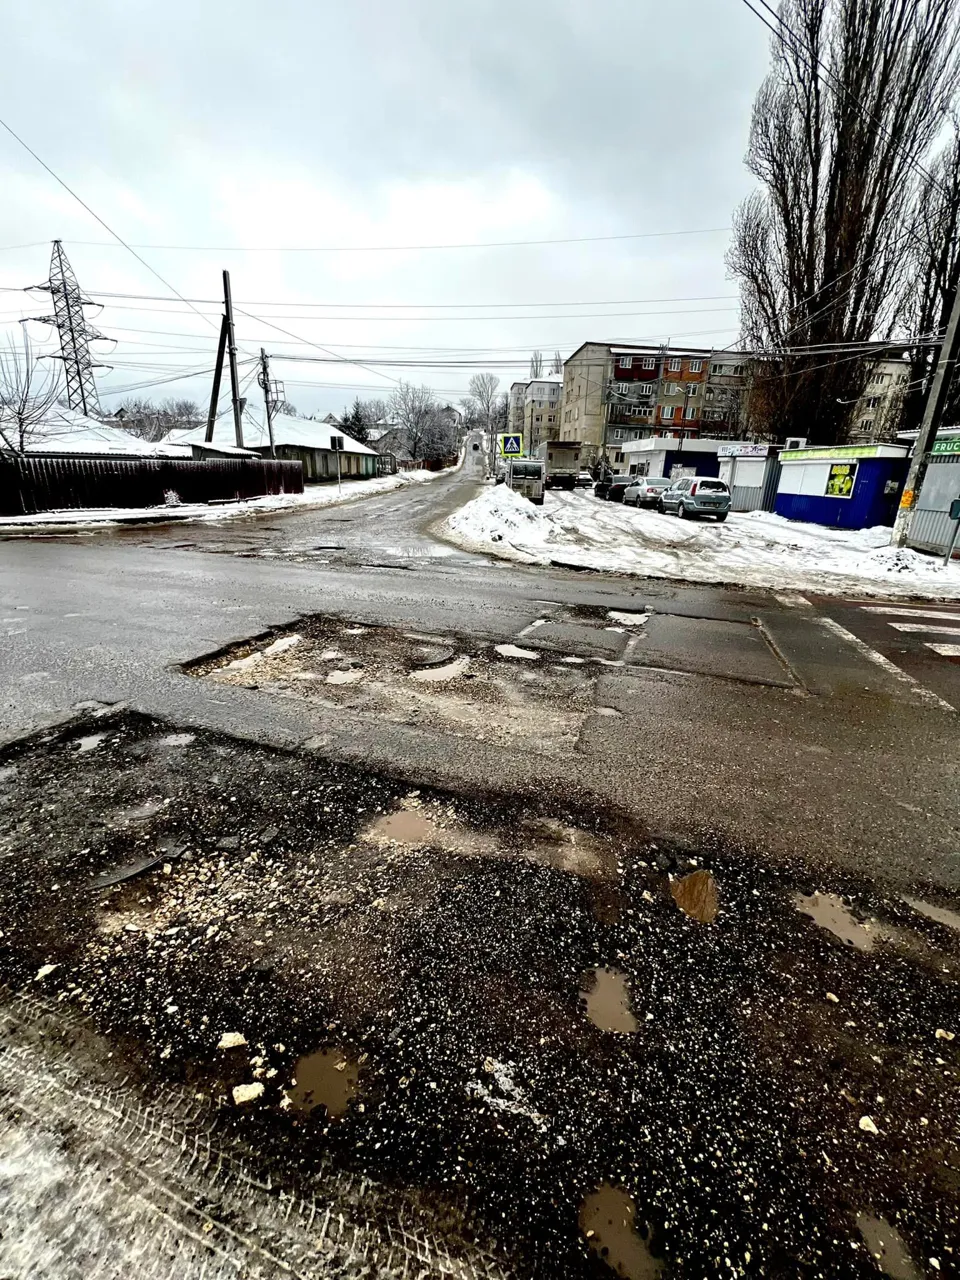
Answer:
xmin=166 ymin=404 xmax=378 ymax=483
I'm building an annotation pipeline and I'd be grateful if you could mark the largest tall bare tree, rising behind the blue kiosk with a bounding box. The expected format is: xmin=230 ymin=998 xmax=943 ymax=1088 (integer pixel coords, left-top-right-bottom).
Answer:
xmin=727 ymin=0 xmax=960 ymax=444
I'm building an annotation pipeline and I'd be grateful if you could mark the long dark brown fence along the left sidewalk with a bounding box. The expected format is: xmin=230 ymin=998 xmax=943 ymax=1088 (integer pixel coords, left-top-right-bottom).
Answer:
xmin=0 ymin=454 xmax=303 ymax=516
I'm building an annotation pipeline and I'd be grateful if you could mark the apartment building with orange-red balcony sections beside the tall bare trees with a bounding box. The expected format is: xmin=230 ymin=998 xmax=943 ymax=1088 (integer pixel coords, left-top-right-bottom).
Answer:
xmin=559 ymin=343 xmax=748 ymax=465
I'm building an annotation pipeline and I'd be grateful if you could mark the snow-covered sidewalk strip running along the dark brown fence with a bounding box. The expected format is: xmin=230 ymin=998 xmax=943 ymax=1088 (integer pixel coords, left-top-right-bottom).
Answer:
xmin=0 ymin=470 xmax=451 ymax=534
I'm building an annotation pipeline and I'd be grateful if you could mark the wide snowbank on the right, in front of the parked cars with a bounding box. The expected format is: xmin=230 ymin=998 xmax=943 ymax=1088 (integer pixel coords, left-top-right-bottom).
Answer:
xmin=447 ymin=485 xmax=960 ymax=599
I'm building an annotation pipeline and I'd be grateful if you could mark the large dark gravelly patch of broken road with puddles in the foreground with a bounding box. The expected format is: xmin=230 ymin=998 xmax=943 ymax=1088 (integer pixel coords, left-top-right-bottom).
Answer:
xmin=0 ymin=711 xmax=960 ymax=1280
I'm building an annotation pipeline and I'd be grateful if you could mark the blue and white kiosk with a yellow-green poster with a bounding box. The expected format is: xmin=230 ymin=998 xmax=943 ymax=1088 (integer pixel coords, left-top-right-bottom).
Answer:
xmin=773 ymin=444 xmax=909 ymax=529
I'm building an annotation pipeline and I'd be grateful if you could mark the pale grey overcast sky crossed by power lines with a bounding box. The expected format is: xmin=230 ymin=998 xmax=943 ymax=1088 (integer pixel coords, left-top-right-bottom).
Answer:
xmin=0 ymin=0 xmax=769 ymax=412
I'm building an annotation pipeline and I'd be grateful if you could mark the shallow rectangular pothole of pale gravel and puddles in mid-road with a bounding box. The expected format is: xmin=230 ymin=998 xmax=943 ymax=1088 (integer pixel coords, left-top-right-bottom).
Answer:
xmin=184 ymin=617 xmax=594 ymax=754
